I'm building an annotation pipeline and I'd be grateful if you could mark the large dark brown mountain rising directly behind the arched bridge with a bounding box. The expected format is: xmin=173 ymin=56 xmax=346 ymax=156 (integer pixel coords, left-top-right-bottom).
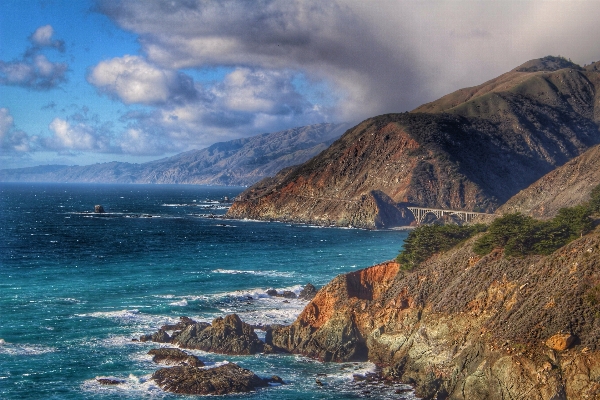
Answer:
xmin=228 ymin=56 xmax=600 ymax=228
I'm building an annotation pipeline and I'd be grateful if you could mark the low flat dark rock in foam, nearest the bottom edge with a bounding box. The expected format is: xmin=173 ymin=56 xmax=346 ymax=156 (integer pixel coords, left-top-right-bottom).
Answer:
xmin=152 ymin=363 xmax=268 ymax=395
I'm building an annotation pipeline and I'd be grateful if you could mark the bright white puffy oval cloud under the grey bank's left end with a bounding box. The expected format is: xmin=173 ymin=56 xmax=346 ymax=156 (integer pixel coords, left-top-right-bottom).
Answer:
xmin=87 ymin=55 xmax=196 ymax=104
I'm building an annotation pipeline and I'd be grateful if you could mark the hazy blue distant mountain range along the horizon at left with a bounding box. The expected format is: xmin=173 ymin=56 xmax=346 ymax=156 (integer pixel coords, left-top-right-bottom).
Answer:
xmin=0 ymin=124 xmax=348 ymax=186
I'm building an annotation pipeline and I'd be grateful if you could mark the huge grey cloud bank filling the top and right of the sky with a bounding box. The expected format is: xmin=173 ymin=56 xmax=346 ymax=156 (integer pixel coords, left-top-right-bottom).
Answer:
xmin=99 ymin=0 xmax=600 ymax=118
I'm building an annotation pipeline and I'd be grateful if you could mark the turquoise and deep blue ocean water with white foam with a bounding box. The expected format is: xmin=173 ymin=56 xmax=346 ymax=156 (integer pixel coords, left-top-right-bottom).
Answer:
xmin=0 ymin=183 xmax=412 ymax=399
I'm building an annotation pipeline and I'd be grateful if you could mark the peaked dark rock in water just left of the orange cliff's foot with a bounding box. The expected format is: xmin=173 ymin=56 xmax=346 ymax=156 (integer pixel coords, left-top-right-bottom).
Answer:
xmin=173 ymin=314 xmax=264 ymax=355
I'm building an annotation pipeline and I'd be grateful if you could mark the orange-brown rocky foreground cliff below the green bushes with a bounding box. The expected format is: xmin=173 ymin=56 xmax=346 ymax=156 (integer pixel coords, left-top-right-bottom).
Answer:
xmin=268 ymin=229 xmax=600 ymax=400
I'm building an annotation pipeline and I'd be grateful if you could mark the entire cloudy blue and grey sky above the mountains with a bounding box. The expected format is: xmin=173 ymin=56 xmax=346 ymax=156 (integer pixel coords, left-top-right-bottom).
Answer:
xmin=0 ymin=0 xmax=600 ymax=168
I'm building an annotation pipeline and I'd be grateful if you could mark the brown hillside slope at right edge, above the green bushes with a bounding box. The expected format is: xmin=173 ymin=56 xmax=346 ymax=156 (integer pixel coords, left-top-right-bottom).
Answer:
xmin=496 ymin=145 xmax=600 ymax=219
